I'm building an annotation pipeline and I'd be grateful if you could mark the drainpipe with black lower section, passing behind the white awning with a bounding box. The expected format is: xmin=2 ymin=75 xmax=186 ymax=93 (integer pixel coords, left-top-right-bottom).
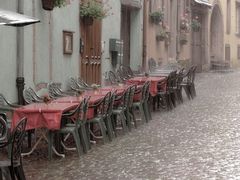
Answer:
xmin=16 ymin=0 xmax=25 ymax=104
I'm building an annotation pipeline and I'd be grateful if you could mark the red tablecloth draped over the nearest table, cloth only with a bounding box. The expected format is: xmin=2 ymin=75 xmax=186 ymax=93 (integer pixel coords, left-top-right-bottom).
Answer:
xmin=12 ymin=103 xmax=78 ymax=130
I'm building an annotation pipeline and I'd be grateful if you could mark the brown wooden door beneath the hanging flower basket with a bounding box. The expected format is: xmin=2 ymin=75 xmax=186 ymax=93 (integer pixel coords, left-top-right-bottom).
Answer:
xmin=80 ymin=19 xmax=102 ymax=84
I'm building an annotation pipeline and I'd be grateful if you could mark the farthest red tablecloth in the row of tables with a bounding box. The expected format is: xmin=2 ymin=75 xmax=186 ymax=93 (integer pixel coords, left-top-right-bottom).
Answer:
xmin=127 ymin=76 xmax=166 ymax=96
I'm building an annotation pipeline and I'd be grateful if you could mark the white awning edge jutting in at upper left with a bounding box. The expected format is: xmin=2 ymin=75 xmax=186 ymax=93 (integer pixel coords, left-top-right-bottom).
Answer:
xmin=0 ymin=9 xmax=40 ymax=26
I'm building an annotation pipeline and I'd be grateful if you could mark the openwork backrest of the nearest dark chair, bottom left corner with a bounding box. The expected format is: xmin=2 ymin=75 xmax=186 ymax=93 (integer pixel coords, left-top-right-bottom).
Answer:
xmin=10 ymin=118 xmax=27 ymax=164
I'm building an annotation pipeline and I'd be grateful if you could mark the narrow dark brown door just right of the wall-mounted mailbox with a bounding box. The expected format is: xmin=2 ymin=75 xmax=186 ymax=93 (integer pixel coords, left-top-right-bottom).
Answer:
xmin=121 ymin=6 xmax=131 ymax=66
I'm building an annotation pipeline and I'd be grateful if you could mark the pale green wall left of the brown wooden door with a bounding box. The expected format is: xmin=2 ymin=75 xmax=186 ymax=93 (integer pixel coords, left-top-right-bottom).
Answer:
xmin=0 ymin=0 xmax=80 ymax=102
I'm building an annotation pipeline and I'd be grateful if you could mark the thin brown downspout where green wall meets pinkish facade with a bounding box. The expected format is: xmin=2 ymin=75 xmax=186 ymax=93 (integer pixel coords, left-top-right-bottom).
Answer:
xmin=142 ymin=0 xmax=148 ymax=71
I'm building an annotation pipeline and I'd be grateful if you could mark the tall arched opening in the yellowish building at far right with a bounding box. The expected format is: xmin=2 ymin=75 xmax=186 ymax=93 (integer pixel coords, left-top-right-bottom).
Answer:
xmin=210 ymin=4 xmax=224 ymax=61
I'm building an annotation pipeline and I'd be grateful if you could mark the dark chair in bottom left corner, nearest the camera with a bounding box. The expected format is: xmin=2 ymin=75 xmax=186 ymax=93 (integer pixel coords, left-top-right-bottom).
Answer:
xmin=0 ymin=118 xmax=27 ymax=180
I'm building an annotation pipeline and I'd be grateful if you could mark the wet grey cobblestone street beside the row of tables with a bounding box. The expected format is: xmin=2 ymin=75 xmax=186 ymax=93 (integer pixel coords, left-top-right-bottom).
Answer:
xmin=23 ymin=72 xmax=240 ymax=180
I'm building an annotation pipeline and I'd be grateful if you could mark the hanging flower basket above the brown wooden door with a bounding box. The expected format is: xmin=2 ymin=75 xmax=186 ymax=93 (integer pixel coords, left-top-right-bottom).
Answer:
xmin=80 ymin=0 xmax=109 ymax=25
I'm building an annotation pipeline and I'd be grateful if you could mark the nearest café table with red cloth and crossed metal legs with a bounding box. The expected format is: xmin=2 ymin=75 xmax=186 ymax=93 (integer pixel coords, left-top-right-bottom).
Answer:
xmin=11 ymin=102 xmax=78 ymax=159
